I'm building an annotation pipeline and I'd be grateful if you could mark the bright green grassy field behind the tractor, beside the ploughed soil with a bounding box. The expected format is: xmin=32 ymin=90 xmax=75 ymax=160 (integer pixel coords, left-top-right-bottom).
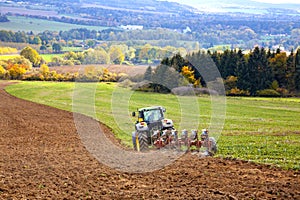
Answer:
xmin=7 ymin=82 xmax=300 ymax=169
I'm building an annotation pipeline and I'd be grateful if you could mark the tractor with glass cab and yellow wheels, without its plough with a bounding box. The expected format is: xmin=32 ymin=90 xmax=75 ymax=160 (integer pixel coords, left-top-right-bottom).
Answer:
xmin=132 ymin=106 xmax=175 ymax=151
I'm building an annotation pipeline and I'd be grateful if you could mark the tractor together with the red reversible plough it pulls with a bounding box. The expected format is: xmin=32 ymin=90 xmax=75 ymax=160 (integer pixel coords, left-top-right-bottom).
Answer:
xmin=132 ymin=106 xmax=217 ymax=156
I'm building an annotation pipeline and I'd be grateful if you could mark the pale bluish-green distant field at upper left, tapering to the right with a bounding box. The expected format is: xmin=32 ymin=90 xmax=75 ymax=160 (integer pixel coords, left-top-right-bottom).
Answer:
xmin=0 ymin=16 xmax=110 ymax=33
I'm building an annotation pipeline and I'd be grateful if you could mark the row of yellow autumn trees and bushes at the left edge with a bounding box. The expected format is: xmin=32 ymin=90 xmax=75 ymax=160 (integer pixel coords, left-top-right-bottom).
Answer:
xmin=0 ymin=47 xmax=123 ymax=82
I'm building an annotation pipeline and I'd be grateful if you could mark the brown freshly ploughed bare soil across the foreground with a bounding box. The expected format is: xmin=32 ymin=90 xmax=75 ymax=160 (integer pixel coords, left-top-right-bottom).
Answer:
xmin=0 ymin=82 xmax=300 ymax=199
